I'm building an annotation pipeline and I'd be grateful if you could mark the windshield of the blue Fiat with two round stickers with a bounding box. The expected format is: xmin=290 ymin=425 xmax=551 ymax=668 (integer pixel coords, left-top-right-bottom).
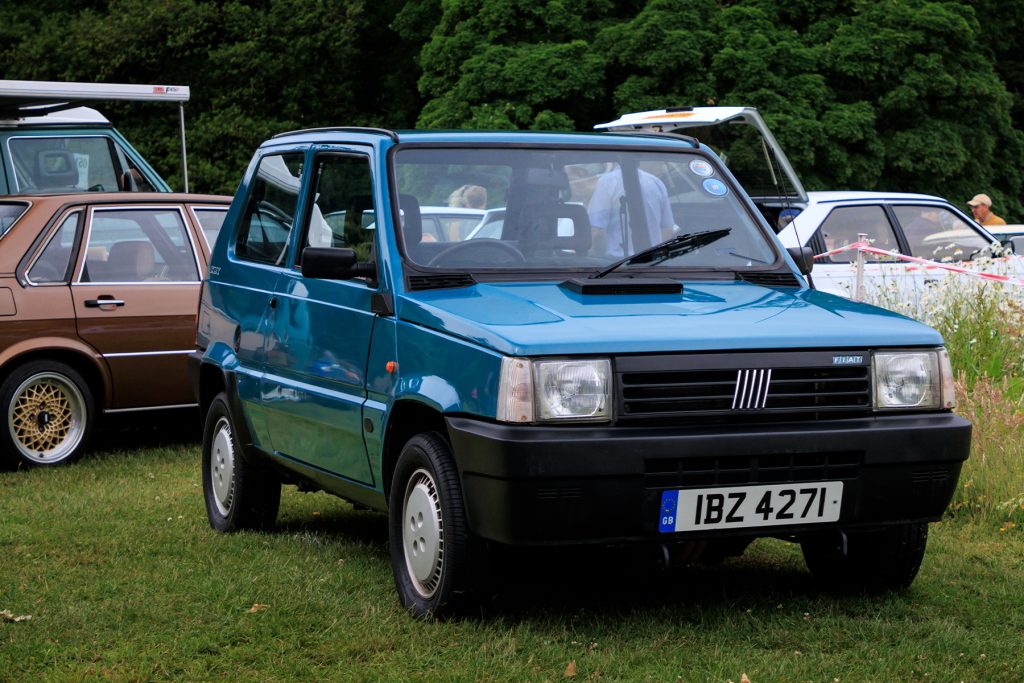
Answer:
xmin=395 ymin=146 xmax=777 ymax=273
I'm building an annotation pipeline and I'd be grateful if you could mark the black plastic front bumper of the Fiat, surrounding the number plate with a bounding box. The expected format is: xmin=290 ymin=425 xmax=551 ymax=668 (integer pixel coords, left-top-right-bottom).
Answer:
xmin=447 ymin=413 xmax=971 ymax=545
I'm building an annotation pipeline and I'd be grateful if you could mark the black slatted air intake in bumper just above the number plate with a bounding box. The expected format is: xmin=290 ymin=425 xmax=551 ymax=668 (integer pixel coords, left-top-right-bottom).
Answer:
xmin=644 ymin=452 xmax=862 ymax=488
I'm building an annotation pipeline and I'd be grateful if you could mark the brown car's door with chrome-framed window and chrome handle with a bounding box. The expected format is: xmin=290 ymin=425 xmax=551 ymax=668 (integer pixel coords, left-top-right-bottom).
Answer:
xmin=72 ymin=205 xmax=201 ymax=410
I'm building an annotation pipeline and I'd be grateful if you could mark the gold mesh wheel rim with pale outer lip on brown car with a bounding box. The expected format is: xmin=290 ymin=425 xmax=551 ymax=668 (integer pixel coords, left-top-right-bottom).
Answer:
xmin=7 ymin=373 xmax=88 ymax=465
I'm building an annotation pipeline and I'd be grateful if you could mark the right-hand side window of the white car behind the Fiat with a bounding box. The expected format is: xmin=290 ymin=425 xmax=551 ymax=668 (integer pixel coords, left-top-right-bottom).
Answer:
xmin=893 ymin=206 xmax=990 ymax=261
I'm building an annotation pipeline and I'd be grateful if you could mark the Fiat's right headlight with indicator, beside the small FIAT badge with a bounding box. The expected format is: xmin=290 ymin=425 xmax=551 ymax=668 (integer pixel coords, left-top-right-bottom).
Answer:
xmin=873 ymin=348 xmax=955 ymax=411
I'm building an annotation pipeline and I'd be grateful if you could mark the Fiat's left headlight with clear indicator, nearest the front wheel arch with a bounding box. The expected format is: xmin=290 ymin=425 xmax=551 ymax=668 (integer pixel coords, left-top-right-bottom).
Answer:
xmin=497 ymin=357 xmax=611 ymax=422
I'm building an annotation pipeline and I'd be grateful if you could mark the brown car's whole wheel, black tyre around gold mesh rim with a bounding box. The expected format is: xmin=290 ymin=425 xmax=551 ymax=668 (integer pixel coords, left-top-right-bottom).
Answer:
xmin=0 ymin=360 xmax=96 ymax=467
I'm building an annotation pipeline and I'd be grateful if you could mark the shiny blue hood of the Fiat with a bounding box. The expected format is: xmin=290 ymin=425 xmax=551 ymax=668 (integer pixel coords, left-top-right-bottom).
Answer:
xmin=397 ymin=281 xmax=942 ymax=355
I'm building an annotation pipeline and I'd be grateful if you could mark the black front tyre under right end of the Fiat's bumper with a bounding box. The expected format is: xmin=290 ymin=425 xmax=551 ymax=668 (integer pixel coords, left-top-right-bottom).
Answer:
xmin=800 ymin=522 xmax=928 ymax=593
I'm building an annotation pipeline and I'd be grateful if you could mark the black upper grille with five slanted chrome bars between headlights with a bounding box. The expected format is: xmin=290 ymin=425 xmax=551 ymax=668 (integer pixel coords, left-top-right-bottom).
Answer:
xmin=615 ymin=350 xmax=871 ymax=425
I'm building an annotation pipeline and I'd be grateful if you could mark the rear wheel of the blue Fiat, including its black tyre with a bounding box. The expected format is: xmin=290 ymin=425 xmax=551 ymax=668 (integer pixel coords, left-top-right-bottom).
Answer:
xmin=203 ymin=393 xmax=281 ymax=531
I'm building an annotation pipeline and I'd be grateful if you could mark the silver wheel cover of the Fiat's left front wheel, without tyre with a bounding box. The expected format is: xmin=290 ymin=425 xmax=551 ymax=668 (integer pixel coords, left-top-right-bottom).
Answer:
xmin=401 ymin=469 xmax=444 ymax=598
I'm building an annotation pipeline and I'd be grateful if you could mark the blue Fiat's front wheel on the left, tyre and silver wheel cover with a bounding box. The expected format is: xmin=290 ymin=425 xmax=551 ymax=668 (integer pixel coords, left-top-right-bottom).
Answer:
xmin=388 ymin=432 xmax=474 ymax=618
